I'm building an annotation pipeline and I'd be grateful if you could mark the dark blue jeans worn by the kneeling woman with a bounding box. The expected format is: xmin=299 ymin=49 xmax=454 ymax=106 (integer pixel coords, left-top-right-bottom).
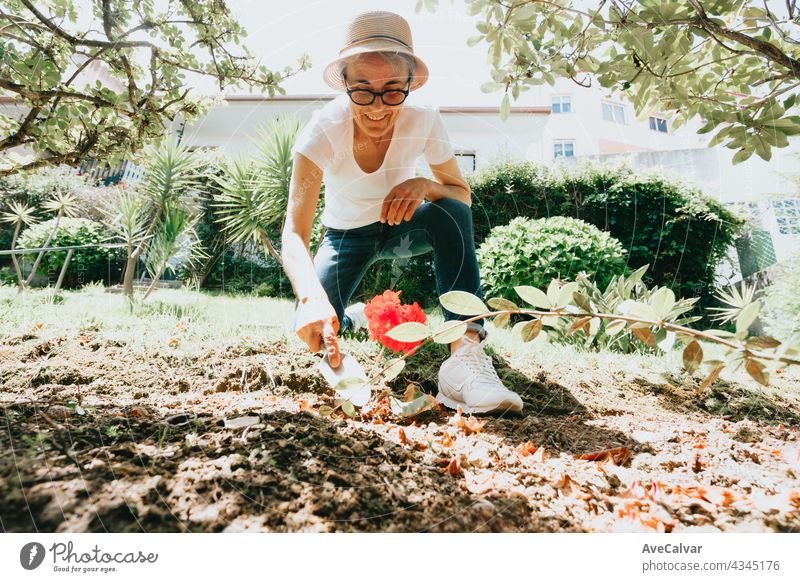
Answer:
xmin=314 ymin=198 xmax=486 ymax=339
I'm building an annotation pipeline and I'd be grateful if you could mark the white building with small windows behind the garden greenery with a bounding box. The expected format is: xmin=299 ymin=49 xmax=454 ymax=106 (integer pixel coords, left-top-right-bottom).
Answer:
xmin=184 ymin=79 xmax=800 ymax=280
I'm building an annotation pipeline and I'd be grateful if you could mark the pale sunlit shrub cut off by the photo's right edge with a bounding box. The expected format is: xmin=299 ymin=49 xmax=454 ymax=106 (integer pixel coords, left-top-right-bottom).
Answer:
xmin=761 ymin=255 xmax=800 ymax=340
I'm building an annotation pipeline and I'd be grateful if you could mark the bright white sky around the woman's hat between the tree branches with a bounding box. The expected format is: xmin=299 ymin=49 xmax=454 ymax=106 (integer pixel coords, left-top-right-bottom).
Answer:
xmin=223 ymin=0 xmax=512 ymax=106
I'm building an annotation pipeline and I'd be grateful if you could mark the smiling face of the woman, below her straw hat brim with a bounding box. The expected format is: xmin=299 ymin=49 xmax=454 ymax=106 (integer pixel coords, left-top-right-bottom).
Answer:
xmin=346 ymin=53 xmax=408 ymax=138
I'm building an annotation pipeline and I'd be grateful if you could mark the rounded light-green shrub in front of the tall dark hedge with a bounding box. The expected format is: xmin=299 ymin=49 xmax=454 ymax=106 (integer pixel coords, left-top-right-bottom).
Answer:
xmin=478 ymin=216 xmax=625 ymax=304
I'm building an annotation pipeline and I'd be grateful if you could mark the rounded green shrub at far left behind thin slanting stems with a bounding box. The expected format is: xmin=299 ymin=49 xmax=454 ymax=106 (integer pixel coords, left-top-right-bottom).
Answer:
xmin=17 ymin=217 xmax=122 ymax=287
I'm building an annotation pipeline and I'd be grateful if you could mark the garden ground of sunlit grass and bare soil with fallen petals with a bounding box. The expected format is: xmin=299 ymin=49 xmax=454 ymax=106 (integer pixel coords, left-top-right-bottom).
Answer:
xmin=0 ymin=287 xmax=800 ymax=531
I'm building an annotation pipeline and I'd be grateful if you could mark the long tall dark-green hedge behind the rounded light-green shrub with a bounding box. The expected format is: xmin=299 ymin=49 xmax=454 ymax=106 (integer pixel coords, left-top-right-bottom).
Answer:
xmin=469 ymin=157 xmax=742 ymax=306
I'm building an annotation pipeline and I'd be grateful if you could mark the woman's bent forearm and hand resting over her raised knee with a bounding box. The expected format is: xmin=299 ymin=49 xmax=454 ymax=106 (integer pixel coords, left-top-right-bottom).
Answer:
xmin=381 ymin=157 xmax=472 ymax=224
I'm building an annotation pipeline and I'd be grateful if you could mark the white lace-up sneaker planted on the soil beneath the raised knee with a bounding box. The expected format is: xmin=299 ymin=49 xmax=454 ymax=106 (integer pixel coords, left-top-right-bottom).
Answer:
xmin=436 ymin=336 xmax=522 ymax=414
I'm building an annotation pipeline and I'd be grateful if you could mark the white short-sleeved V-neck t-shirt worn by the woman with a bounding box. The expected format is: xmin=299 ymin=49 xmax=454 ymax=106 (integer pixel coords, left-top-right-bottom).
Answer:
xmin=292 ymin=93 xmax=453 ymax=229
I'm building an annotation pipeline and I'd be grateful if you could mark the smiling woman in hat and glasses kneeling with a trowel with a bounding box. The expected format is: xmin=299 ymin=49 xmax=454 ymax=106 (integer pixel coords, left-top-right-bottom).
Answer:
xmin=282 ymin=12 xmax=522 ymax=413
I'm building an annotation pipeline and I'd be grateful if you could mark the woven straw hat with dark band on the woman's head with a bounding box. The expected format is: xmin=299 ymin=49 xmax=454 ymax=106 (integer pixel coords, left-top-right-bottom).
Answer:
xmin=322 ymin=10 xmax=428 ymax=91
